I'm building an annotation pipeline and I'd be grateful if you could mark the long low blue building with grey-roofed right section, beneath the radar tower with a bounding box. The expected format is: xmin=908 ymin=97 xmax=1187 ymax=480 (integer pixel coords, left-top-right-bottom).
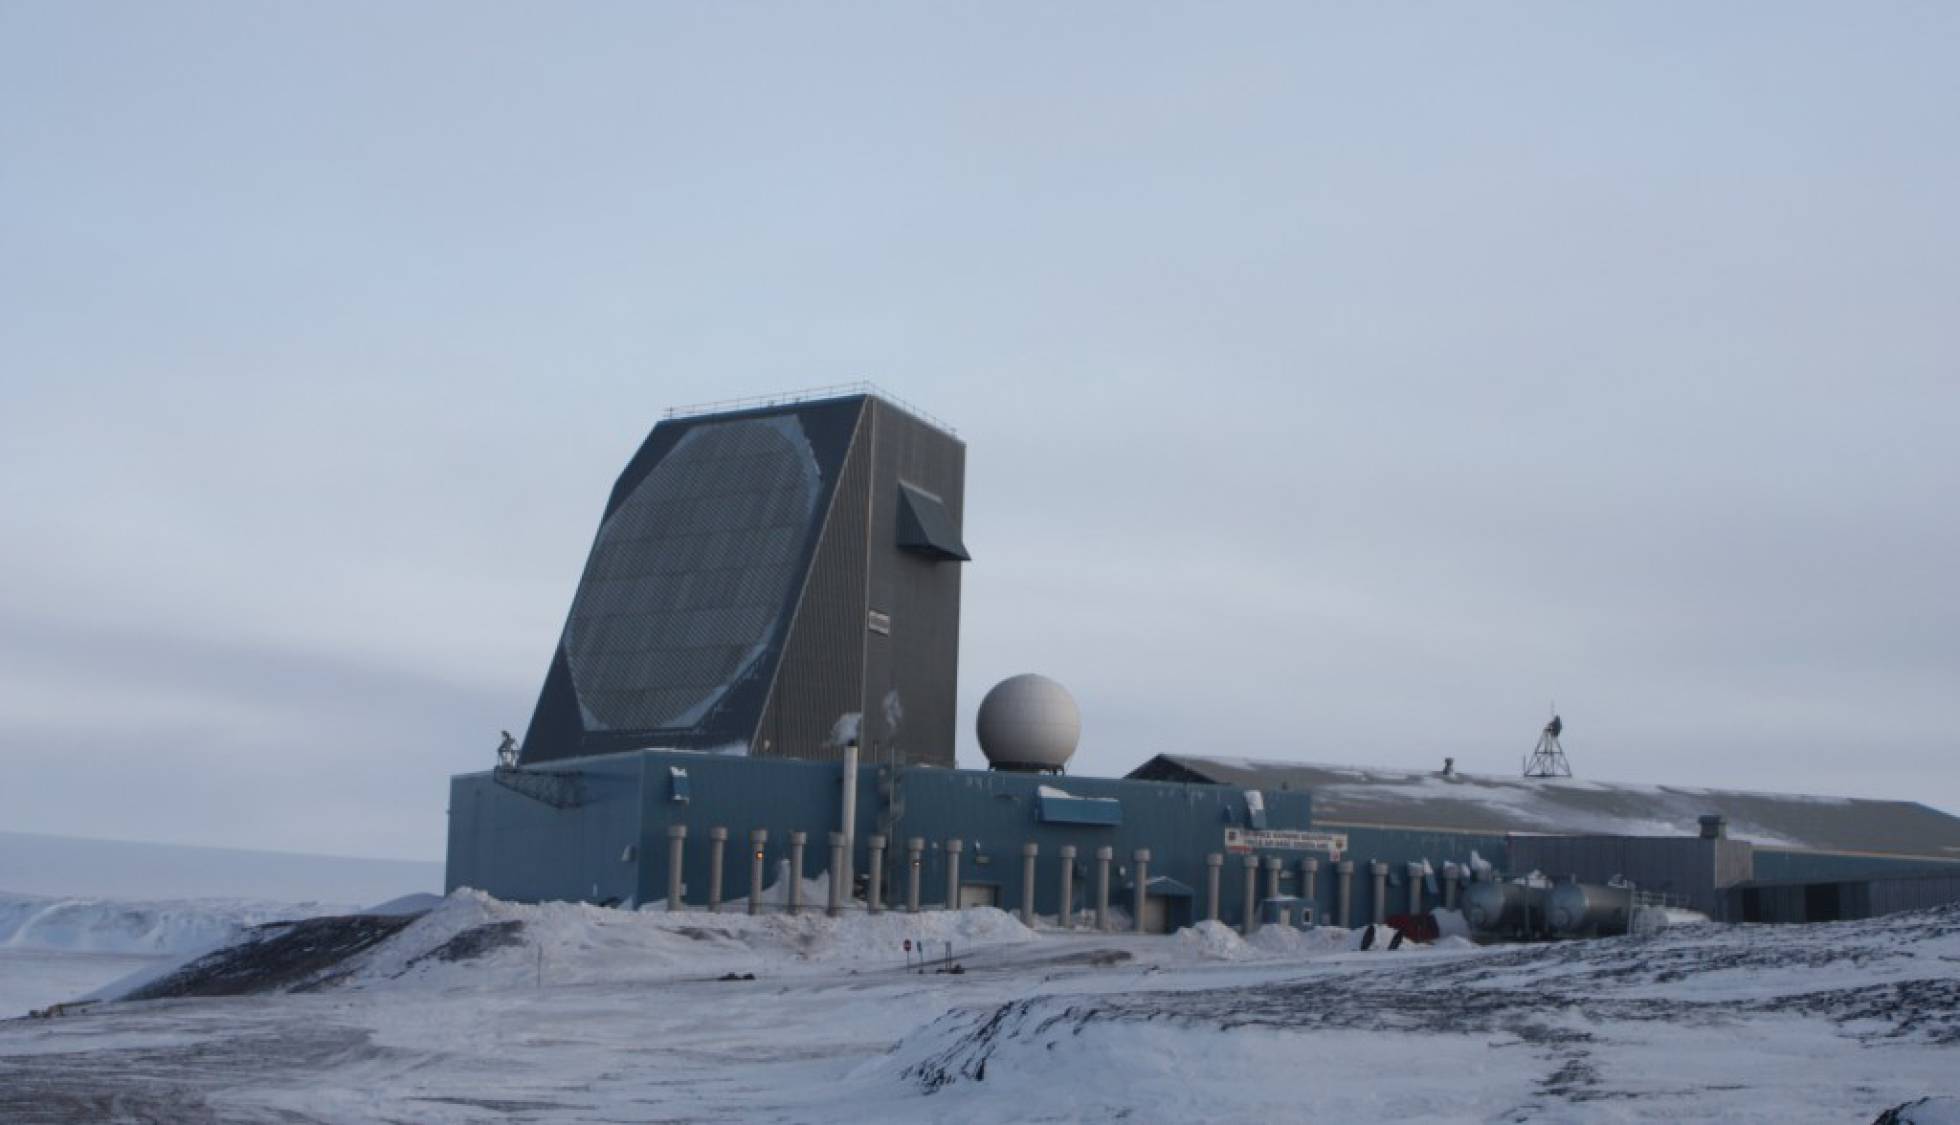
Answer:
xmin=447 ymin=751 xmax=1960 ymax=929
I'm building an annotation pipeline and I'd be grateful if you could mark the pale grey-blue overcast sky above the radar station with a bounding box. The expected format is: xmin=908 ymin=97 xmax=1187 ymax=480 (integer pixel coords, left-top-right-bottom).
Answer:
xmin=0 ymin=0 xmax=1960 ymax=858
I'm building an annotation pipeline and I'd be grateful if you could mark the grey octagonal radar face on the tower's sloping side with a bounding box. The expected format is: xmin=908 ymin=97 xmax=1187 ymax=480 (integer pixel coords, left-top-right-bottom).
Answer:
xmin=564 ymin=416 xmax=823 ymax=731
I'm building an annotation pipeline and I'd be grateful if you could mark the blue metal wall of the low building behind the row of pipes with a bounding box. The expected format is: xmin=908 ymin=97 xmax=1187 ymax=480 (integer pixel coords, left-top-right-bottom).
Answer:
xmin=447 ymin=751 xmax=1505 ymax=925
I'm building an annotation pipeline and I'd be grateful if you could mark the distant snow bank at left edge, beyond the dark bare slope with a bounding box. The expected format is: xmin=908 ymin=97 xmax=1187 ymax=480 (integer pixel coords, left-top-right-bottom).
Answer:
xmin=0 ymin=894 xmax=349 ymax=956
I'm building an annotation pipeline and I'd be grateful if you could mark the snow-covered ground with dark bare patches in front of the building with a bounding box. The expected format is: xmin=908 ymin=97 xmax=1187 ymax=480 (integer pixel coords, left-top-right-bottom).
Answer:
xmin=0 ymin=892 xmax=1960 ymax=1123
